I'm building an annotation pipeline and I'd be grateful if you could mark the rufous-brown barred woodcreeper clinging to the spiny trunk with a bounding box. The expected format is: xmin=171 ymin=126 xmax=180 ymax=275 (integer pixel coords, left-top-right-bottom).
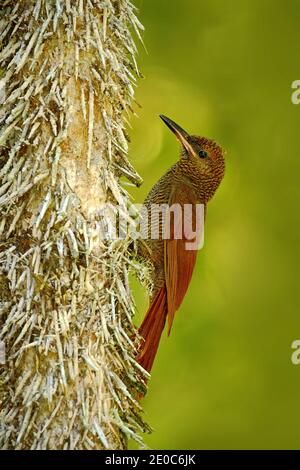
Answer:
xmin=137 ymin=115 xmax=225 ymax=372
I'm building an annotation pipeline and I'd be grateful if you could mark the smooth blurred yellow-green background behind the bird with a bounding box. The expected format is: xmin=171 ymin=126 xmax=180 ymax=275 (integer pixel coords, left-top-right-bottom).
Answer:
xmin=130 ymin=0 xmax=300 ymax=449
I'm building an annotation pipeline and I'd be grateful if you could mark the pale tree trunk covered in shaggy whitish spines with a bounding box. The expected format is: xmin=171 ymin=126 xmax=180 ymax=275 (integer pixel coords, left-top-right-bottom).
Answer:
xmin=0 ymin=0 xmax=145 ymax=449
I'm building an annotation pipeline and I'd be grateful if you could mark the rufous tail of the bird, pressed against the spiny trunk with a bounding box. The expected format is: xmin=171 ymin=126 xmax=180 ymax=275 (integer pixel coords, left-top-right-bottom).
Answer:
xmin=136 ymin=286 xmax=168 ymax=372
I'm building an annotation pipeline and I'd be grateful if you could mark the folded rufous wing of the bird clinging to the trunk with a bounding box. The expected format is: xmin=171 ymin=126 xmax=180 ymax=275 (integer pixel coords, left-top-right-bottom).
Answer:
xmin=164 ymin=185 xmax=204 ymax=334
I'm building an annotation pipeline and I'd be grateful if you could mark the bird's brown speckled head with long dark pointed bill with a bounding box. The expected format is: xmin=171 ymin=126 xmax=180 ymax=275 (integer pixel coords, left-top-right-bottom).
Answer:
xmin=160 ymin=115 xmax=225 ymax=199
